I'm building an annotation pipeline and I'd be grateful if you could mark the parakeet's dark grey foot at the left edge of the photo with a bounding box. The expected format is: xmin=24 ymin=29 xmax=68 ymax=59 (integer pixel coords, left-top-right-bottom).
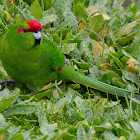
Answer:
xmin=0 ymin=80 xmax=16 ymax=90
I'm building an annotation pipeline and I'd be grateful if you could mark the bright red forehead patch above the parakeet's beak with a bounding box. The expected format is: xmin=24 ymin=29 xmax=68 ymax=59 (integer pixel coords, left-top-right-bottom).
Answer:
xmin=25 ymin=20 xmax=42 ymax=32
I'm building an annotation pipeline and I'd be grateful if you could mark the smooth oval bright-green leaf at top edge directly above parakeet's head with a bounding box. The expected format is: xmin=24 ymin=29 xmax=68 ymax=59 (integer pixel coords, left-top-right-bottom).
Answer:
xmin=30 ymin=0 xmax=42 ymax=20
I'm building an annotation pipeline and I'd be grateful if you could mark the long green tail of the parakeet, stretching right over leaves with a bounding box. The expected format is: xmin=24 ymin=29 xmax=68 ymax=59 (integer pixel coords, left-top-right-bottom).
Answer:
xmin=58 ymin=65 xmax=140 ymax=99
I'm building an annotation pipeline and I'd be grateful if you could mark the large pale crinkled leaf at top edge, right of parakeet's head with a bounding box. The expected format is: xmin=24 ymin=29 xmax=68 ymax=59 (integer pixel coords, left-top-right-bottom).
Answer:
xmin=53 ymin=0 xmax=78 ymax=33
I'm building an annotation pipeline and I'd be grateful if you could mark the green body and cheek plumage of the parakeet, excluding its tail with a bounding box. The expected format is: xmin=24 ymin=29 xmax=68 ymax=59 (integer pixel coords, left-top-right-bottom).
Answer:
xmin=0 ymin=21 xmax=65 ymax=90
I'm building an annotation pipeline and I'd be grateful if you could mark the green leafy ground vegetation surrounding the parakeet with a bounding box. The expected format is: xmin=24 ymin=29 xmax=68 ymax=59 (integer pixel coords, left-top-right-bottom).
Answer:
xmin=0 ymin=0 xmax=140 ymax=140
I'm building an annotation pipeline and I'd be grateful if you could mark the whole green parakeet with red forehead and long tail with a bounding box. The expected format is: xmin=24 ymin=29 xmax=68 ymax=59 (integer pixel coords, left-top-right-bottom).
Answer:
xmin=0 ymin=20 xmax=140 ymax=99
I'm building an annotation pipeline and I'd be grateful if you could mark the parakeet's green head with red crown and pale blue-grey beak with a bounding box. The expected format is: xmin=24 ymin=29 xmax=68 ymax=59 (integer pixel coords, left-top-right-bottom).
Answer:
xmin=7 ymin=20 xmax=42 ymax=49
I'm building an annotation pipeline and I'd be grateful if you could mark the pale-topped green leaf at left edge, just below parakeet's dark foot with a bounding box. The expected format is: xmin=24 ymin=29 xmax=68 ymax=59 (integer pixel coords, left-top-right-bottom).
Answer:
xmin=0 ymin=89 xmax=20 ymax=112
